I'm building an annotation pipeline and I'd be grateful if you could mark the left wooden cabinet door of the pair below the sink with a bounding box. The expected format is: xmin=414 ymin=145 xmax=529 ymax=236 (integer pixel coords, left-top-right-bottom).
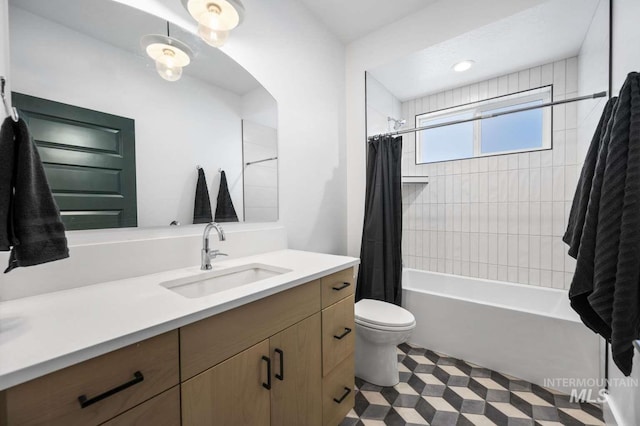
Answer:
xmin=182 ymin=340 xmax=273 ymax=426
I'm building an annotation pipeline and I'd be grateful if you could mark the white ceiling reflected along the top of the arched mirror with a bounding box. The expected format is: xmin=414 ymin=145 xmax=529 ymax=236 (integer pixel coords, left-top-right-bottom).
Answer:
xmin=10 ymin=0 xmax=262 ymax=95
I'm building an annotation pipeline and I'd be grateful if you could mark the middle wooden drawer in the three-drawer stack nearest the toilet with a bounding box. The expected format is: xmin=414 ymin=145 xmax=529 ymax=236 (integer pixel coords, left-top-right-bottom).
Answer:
xmin=322 ymin=295 xmax=356 ymax=376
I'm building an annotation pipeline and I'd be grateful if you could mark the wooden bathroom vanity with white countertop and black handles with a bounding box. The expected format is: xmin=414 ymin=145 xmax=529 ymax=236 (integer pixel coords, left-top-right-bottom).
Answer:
xmin=0 ymin=250 xmax=358 ymax=426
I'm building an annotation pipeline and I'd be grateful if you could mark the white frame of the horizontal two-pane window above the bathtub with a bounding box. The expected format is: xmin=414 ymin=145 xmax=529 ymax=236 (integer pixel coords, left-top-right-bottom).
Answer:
xmin=415 ymin=85 xmax=553 ymax=164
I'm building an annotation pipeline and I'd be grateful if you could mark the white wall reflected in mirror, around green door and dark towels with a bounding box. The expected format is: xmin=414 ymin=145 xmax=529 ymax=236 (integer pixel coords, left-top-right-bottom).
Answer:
xmin=10 ymin=6 xmax=242 ymax=227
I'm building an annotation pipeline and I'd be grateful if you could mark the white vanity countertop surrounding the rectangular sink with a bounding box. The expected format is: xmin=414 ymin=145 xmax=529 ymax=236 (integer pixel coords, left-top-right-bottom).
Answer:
xmin=0 ymin=250 xmax=359 ymax=390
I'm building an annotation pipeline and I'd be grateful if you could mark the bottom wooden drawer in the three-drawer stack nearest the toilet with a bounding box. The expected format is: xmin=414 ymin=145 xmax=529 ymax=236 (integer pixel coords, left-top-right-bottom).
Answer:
xmin=322 ymin=354 xmax=355 ymax=426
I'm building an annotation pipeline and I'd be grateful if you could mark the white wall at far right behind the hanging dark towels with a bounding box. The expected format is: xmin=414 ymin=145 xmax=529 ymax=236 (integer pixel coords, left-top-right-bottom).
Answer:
xmin=608 ymin=0 xmax=640 ymax=426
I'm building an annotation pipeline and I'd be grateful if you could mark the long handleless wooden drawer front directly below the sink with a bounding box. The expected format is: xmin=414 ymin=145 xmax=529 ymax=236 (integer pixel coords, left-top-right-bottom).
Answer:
xmin=180 ymin=280 xmax=320 ymax=380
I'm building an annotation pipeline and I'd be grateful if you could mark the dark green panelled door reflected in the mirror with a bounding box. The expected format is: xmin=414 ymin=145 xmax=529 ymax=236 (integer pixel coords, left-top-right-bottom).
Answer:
xmin=12 ymin=93 xmax=137 ymax=230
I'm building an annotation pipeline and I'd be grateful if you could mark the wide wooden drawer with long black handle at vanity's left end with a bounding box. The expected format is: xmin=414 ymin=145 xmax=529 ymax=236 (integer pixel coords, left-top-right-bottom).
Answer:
xmin=5 ymin=331 xmax=179 ymax=426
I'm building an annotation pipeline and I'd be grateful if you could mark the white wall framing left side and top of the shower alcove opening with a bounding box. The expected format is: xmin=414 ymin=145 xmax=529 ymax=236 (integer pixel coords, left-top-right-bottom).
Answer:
xmin=348 ymin=0 xmax=543 ymax=256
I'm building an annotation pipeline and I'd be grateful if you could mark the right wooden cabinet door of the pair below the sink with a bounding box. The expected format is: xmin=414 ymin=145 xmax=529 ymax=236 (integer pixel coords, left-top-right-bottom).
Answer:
xmin=269 ymin=313 xmax=322 ymax=426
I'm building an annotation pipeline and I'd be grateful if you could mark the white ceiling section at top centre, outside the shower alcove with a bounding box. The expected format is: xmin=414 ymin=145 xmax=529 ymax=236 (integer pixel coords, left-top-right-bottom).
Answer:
xmin=300 ymin=0 xmax=437 ymax=44
